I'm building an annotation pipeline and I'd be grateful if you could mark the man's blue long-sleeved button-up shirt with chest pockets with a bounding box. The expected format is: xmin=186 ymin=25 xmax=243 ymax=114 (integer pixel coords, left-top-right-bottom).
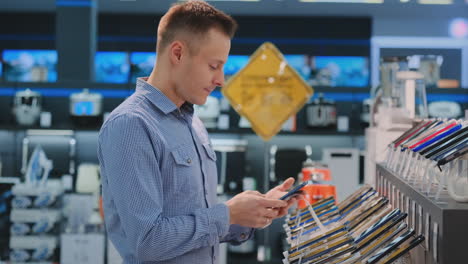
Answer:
xmin=98 ymin=79 xmax=252 ymax=264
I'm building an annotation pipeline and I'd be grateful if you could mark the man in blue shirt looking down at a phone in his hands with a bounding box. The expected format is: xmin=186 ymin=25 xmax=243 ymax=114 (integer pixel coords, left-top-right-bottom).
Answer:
xmin=98 ymin=1 xmax=295 ymax=264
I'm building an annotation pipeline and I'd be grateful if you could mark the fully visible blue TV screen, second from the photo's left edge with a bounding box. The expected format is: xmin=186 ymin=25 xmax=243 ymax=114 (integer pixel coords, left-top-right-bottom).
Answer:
xmin=94 ymin=51 xmax=130 ymax=83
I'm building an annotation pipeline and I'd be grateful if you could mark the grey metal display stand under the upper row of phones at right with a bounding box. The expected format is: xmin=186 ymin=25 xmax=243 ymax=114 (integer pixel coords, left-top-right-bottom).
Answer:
xmin=376 ymin=164 xmax=468 ymax=264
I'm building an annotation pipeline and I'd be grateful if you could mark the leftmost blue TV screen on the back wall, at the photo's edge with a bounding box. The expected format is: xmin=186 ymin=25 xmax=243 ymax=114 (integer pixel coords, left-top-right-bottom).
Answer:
xmin=2 ymin=50 xmax=57 ymax=82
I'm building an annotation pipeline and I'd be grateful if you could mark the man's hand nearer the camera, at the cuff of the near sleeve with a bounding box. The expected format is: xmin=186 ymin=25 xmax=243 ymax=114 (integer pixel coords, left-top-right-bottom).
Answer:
xmin=226 ymin=191 xmax=288 ymax=228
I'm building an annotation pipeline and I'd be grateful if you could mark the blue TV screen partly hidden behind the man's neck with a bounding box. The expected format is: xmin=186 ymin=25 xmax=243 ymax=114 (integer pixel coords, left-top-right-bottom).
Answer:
xmin=130 ymin=52 xmax=156 ymax=83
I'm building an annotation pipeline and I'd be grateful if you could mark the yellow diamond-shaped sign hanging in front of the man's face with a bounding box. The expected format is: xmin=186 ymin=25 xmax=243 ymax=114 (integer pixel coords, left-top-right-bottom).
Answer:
xmin=222 ymin=42 xmax=313 ymax=140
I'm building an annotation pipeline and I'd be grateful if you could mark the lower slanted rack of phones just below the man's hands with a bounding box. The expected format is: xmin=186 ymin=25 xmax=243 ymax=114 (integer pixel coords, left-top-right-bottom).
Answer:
xmin=283 ymin=185 xmax=425 ymax=264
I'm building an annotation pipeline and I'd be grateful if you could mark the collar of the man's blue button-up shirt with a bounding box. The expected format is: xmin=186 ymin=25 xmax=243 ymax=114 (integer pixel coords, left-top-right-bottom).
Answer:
xmin=136 ymin=77 xmax=193 ymax=115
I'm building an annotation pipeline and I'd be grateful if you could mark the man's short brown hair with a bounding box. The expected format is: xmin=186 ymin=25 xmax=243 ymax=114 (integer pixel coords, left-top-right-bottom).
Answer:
xmin=156 ymin=1 xmax=237 ymax=53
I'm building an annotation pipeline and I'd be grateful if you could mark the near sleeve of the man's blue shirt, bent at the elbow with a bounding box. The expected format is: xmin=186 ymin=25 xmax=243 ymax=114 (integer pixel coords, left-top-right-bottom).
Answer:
xmin=98 ymin=115 xmax=229 ymax=261
